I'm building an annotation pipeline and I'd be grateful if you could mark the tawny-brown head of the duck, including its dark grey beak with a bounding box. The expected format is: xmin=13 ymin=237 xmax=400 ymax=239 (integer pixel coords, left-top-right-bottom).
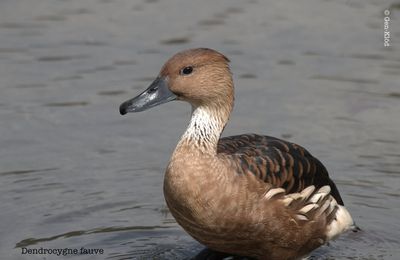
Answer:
xmin=119 ymin=48 xmax=233 ymax=115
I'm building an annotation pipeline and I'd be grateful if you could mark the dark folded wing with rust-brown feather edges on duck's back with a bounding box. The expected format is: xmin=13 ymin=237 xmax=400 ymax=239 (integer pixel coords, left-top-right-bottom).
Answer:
xmin=218 ymin=134 xmax=343 ymax=205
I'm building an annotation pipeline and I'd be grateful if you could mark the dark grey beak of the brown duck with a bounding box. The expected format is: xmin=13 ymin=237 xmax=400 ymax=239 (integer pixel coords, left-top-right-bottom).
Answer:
xmin=119 ymin=77 xmax=176 ymax=115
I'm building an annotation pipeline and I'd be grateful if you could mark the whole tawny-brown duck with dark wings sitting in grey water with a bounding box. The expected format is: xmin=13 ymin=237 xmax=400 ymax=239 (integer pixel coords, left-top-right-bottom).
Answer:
xmin=119 ymin=48 xmax=355 ymax=260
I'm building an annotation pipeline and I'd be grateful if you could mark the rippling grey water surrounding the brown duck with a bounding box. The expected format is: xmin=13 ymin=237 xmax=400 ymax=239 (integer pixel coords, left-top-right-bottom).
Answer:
xmin=0 ymin=0 xmax=400 ymax=260
